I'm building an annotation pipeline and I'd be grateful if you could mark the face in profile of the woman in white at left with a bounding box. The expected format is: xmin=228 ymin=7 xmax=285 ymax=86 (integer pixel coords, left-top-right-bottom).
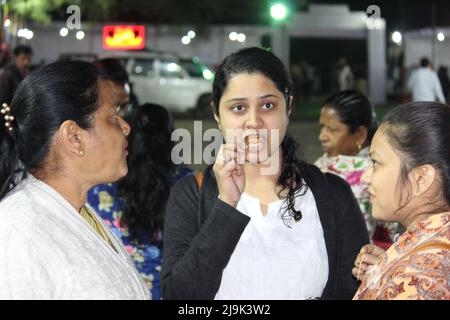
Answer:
xmin=84 ymin=81 xmax=130 ymax=184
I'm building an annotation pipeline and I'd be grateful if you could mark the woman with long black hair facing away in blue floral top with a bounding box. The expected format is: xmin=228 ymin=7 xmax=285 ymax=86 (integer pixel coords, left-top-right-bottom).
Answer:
xmin=88 ymin=104 xmax=193 ymax=300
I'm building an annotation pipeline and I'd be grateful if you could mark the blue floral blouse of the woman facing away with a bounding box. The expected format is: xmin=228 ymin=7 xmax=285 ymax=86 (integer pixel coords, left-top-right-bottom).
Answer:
xmin=87 ymin=166 xmax=194 ymax=300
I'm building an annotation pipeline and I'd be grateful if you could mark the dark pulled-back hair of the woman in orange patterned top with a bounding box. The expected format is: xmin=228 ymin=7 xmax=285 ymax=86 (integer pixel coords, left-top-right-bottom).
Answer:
xmin=380 ymin=102 xmax=450 ymax=209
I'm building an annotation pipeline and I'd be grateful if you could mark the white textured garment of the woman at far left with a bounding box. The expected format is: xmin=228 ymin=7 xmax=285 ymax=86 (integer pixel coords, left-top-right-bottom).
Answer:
xmin=0 ymin=174 xmax=149 ymax=299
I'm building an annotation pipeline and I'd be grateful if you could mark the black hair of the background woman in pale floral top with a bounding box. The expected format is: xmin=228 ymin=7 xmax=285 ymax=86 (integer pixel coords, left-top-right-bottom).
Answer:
xmin=323 ymin=90 xmax=378 ymax=147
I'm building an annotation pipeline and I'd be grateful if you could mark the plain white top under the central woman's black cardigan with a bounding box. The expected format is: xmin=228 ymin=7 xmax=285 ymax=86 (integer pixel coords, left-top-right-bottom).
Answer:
xmin=215 ymin=189 xmax=328 ymax=300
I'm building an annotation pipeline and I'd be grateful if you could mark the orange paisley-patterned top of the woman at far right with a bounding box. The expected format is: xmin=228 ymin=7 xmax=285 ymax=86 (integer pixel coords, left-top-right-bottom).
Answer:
xmin=353 ymin=212 xmax=450 ymax=300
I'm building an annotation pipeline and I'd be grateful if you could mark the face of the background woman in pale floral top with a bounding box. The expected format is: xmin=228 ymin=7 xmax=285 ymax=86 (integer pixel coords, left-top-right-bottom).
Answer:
xmin=319 ymin=106 xmax=364 ymax=157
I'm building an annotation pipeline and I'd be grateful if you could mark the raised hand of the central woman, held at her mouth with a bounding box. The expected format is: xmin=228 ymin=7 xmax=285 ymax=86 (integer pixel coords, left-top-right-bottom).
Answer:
xmin=213 ymin=144 xmax=245 ymax=207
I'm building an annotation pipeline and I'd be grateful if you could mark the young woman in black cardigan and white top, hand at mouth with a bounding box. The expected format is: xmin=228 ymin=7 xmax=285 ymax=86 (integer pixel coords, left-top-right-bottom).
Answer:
xmin=161 ymin=48 xmax=368 ymax=299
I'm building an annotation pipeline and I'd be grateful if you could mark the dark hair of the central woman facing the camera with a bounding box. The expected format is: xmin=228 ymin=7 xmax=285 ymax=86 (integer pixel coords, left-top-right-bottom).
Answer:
xmin=212 ymin=47 xmax=307 ymax=221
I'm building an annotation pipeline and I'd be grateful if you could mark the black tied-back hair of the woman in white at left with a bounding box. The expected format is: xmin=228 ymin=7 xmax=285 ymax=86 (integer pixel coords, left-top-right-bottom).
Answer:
xmin=0 ymin=61 xmax=101 ymax=200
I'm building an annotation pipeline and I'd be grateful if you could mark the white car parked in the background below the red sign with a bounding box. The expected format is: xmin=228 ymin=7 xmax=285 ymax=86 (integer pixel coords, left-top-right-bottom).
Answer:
xmin=111 ymin=51 xmax=213 ymax=115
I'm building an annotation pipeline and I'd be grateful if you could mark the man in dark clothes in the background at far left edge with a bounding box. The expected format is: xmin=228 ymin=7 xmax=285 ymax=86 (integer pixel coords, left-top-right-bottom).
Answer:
xmin=0 ymin=45 xmax=33 ymax=104
